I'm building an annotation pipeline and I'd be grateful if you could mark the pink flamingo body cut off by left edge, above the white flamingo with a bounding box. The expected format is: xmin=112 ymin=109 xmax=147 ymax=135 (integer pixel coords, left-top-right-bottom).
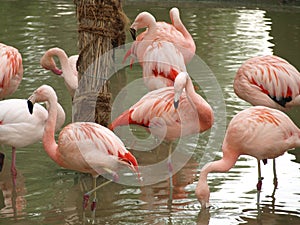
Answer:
xmin=0 ymin=43 xmax=23 ymax=99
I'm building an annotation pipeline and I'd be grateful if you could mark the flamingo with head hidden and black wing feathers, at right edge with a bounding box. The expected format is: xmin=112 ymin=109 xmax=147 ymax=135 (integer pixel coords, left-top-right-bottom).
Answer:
xmin=234 ymin=55 xmax=300 ymax=111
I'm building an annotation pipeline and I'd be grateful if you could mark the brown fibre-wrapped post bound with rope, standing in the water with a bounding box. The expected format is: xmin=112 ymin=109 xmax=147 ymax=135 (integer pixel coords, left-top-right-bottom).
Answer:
xmin=72 ymin=0 xmax=128 ymax=126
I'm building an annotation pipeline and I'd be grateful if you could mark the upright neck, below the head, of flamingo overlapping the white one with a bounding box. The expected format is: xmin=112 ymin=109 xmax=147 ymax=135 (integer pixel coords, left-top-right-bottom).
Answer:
xmin=43 ymin=93 xmax=60 ymax=164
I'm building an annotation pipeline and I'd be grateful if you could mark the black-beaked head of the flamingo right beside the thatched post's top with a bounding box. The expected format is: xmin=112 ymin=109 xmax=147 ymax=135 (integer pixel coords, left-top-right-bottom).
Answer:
xmin=130 ymin=12 xmax=156 ymax=40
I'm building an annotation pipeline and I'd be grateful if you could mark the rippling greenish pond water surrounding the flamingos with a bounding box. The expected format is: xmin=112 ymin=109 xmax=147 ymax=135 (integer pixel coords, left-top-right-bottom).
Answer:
xmin=0 ymin=0 xmax=300 ymax=225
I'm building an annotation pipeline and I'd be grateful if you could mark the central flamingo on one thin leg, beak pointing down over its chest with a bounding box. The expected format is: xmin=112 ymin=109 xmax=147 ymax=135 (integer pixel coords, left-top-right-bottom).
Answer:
xmin=109 ymin=72 xmax=214 ymax=196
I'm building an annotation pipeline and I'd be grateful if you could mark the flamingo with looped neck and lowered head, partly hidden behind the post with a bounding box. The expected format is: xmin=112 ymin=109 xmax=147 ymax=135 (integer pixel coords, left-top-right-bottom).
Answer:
xmin=40 ymin=48 xmax=78 ymax=98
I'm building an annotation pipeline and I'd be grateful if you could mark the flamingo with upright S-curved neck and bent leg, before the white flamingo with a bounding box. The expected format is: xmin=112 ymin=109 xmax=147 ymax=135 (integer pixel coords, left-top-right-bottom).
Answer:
xmin=28 ymin=85 xmax=139 ymax=216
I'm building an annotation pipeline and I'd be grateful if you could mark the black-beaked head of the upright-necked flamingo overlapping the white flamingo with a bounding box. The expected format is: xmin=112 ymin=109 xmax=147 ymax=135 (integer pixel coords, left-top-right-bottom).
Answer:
xmin=27 ymin=85 xmax=57 ymax=114
